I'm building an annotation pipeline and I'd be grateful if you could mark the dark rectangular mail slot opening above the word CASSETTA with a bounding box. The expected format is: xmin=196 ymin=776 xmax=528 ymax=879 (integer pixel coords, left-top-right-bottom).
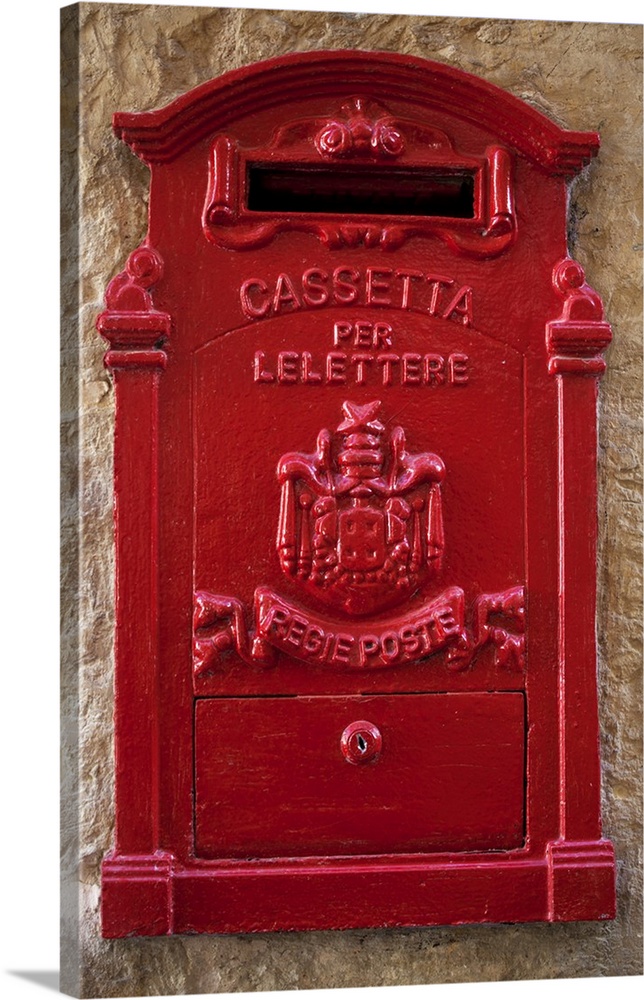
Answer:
xmin=246 ymin=164 xmax=475 ymax=219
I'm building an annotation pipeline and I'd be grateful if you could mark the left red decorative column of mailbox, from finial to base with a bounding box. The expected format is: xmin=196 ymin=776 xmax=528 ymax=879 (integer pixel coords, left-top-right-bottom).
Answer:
xmin=96 ymin=246 xmax=172 ymax=937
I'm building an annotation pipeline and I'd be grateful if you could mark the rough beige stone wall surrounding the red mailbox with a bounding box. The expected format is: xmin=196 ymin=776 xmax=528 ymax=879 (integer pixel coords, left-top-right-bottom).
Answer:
xmin=62 ymin=3 xmax=642 ymax=997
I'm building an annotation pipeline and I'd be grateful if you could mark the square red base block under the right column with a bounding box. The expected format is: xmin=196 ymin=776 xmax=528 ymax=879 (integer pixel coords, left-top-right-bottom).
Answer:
xmin=546 ymin=840 xmax=615 ymax=920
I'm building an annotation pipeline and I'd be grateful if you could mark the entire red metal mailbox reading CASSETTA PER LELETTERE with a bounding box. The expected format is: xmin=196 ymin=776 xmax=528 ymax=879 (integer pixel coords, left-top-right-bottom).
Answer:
xmin=98 ymin=52 xmax=614 ymax=937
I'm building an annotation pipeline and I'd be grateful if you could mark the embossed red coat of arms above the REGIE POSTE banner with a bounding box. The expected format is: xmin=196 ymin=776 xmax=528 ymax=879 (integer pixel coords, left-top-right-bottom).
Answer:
xmin=277 ymin=400 xmax=445 ymax=615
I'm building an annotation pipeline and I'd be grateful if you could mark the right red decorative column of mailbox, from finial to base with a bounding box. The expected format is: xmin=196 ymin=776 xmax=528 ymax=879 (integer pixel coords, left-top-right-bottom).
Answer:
xmin=546 ymin=259 xmax=615 ymax=920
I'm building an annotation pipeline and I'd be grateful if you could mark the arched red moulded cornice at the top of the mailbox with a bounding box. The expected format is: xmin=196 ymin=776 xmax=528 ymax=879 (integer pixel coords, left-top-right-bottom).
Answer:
xmin=113 ymin=50 xmax=599 ymax=176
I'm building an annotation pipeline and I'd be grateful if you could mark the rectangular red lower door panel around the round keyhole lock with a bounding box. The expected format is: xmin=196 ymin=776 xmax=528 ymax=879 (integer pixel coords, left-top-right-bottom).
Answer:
xmin=195 ymin=691 xmax=525 ymax=858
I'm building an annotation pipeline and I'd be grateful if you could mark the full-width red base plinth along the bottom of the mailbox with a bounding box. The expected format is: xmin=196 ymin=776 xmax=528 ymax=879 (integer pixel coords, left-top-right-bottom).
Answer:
xmin=98 ymin=841 xmax=615 ymax=938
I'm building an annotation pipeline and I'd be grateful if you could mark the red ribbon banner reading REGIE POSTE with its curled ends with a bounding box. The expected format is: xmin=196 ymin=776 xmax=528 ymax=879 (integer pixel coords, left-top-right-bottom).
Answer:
xmin=193 ymin=587 xmax=525 ymax=677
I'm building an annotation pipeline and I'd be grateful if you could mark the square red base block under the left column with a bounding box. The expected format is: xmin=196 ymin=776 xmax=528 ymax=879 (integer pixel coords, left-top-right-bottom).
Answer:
xmin=101 ymin=851 xmax=174 ymax=938
